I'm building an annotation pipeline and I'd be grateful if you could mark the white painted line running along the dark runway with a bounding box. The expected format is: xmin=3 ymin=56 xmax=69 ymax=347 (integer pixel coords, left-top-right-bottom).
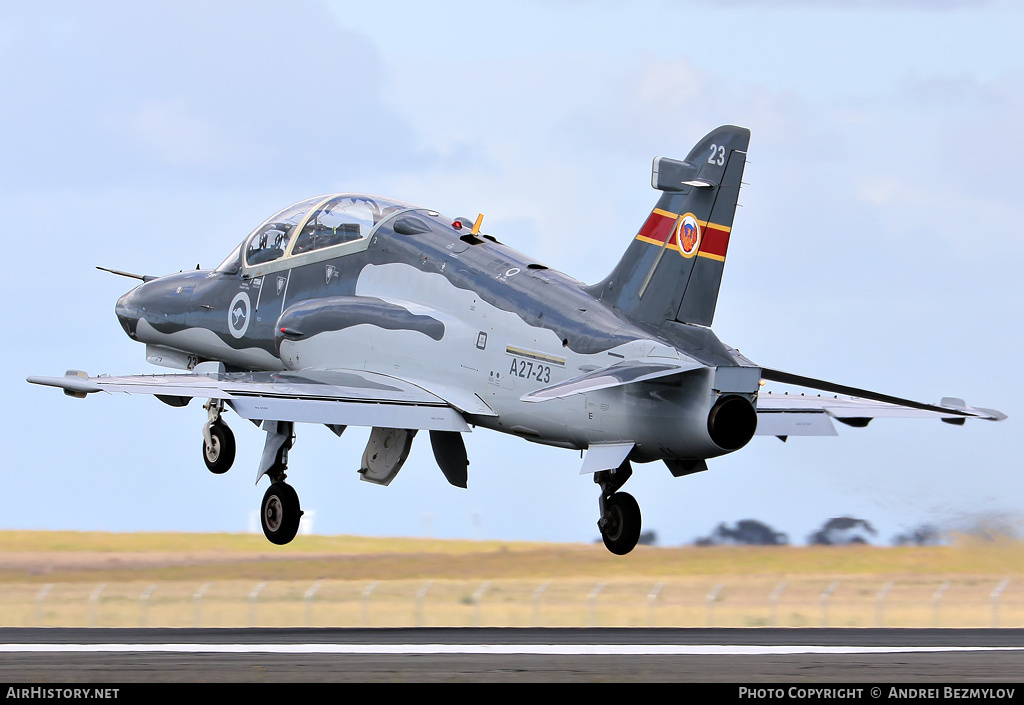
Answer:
xmin=0 ymin=644 xmax=1024 ymax=656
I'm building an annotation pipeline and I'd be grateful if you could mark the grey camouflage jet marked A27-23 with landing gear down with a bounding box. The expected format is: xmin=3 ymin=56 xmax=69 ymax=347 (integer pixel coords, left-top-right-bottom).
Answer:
xmin=29 ymin=126 xmax=1005 ymax=554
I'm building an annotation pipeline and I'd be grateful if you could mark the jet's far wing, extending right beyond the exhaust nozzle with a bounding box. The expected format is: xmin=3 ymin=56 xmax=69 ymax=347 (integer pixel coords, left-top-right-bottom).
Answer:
xmin=757 ymin=369 xmax=1007 ymax=437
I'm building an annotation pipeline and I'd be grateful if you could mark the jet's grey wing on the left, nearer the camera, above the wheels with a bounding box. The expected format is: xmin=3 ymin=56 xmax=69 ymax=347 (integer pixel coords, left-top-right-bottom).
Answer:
xmin=28 ymin=366 xmax=475 ymax=431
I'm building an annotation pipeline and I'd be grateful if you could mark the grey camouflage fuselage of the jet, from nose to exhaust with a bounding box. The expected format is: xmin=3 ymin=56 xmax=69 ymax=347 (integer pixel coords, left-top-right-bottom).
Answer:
xmin=117 ymin=195 xmax=757 ymax=461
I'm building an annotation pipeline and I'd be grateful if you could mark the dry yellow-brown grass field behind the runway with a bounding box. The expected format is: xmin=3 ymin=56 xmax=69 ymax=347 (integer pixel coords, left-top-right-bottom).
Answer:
xmin=0 ymin=532 xmax=1024 ymax=627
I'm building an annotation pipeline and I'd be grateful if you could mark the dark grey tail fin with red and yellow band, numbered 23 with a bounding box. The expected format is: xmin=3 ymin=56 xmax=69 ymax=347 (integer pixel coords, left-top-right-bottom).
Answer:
xmin=588 ymin=125 xmax=751 ymax=326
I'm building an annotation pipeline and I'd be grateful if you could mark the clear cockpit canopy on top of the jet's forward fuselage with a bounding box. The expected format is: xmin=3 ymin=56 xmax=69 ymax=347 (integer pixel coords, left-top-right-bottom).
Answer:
xmin=217 ymin=194 xmax=417 ymax=272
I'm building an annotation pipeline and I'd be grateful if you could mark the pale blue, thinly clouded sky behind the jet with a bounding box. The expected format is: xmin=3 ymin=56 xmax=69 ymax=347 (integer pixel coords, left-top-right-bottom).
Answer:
xmin=0 ymin=0 xmax=1024 ymax=544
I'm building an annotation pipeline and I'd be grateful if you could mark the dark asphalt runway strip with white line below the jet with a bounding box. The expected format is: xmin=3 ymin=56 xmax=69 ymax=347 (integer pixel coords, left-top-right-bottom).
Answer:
xmin=0 ymin=628 xmax=1024 ymax=684
